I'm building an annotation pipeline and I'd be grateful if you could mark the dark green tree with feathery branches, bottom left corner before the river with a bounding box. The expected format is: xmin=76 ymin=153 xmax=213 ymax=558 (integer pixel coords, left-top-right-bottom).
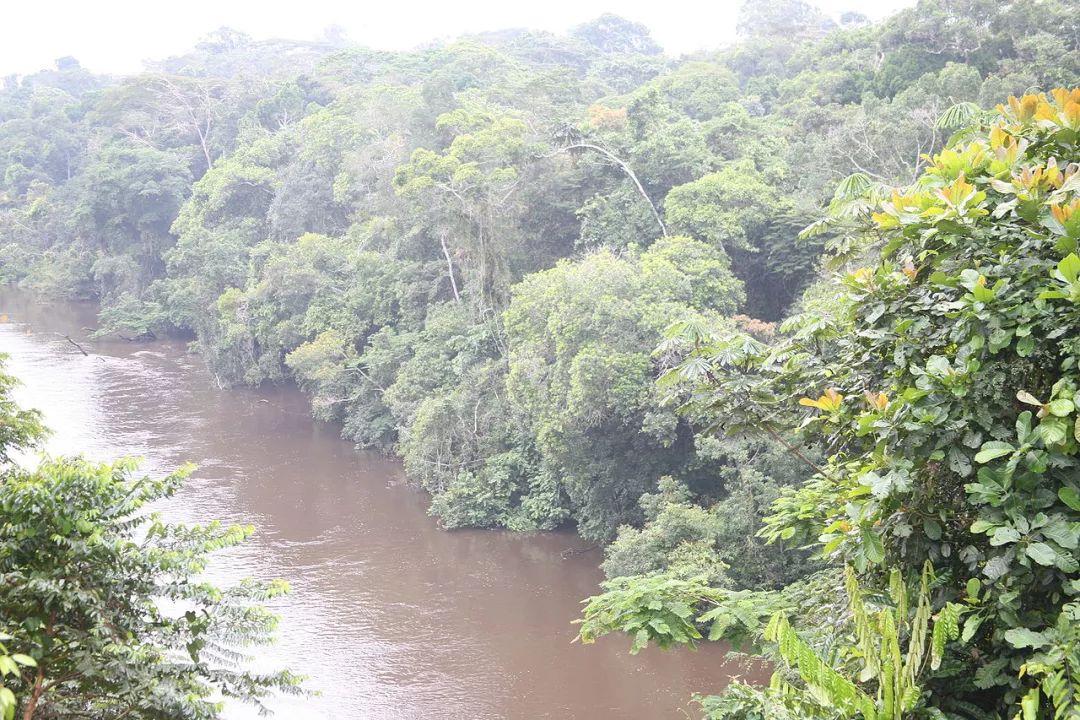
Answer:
xmin=0 ymin=460 xmax=299 ymax=719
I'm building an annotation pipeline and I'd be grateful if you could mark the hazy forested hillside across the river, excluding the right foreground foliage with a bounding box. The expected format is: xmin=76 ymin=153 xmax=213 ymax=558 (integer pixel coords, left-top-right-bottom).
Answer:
xmin=0 ymin=0 xmax=1080 ymax=587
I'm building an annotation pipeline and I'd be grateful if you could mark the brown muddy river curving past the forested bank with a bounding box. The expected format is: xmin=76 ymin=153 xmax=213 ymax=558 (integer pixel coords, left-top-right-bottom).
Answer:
xmin=0 ymin=291 xmax=754 ymax=720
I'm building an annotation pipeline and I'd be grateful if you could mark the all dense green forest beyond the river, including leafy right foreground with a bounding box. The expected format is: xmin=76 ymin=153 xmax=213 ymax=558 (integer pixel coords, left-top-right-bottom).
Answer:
xmin=0 ymin=0 xmax=1080 ymax=720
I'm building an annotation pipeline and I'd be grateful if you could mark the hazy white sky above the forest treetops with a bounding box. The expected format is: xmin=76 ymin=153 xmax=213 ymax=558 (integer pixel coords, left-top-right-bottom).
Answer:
xmin=0 ymin=0 xmax=915 ymax=77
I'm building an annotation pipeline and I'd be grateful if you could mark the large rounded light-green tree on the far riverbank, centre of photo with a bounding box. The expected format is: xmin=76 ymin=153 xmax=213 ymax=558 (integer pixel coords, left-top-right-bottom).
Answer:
xmin=505 ymin=237 xmax=742 ymax=539
